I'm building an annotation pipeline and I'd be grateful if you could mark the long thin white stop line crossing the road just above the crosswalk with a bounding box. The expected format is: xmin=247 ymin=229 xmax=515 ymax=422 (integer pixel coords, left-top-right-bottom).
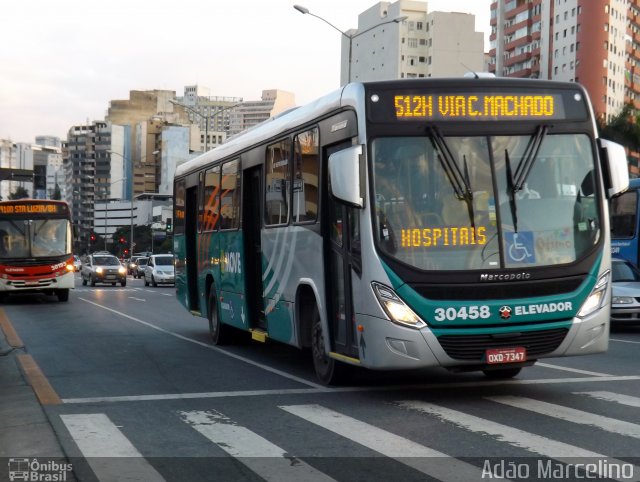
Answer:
xmin=62 ymin=375 xmax=640 ymax=404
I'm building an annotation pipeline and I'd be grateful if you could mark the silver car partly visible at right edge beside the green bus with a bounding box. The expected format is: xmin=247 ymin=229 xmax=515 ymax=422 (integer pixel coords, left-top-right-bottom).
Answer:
xmin=611 ymin=258 xmax=640 ymax=324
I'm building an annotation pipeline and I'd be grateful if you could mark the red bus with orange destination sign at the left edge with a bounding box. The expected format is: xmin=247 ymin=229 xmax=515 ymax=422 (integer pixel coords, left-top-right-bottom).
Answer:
xmin=0 ymin=199 xmax=75 ymax=301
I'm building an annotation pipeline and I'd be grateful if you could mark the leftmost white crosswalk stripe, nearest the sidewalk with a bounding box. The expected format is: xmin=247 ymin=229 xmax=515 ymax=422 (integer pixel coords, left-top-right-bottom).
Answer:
xmin=60 ymin=413 xmax=164 ymax=482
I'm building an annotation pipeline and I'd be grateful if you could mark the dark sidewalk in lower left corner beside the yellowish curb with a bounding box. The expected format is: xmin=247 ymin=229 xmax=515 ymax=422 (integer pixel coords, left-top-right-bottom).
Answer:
xmin=0 ymin=324 xmax=65 ymax=460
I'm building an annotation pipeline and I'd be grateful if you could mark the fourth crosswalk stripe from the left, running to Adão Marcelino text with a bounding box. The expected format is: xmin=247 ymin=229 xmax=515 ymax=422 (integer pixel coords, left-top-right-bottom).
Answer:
xmin=396 ymin=400 xmax=640 ymax=477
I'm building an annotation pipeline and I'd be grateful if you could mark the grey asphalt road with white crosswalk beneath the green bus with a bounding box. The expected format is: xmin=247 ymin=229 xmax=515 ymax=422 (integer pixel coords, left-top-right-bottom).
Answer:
xmin=3 ymin=279 xmax=640 ymax=481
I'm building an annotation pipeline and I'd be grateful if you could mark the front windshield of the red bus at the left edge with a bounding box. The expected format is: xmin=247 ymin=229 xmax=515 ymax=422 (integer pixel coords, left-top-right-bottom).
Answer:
xmin=0 ymin=219 xmax=71 ymax=258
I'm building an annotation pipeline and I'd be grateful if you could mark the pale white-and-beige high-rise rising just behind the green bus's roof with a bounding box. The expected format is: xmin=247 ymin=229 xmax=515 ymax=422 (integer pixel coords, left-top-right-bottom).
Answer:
xmin=340 ymin=0 xmax=485 ymax=85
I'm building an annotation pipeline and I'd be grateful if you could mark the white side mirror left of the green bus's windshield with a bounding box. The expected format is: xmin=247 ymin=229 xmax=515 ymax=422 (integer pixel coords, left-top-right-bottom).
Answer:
xmin=329 ymin=145 xmax=364 ymax=208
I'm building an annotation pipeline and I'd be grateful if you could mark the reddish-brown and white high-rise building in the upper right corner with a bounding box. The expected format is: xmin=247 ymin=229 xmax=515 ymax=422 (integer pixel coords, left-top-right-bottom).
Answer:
xmin=489 ymin=0 xmax=640 ymax=120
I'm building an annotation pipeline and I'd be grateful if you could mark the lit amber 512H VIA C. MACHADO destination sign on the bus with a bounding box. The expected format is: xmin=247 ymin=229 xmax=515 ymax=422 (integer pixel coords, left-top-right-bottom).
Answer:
xmin=369 ymin=89 xmax=588 ymax=122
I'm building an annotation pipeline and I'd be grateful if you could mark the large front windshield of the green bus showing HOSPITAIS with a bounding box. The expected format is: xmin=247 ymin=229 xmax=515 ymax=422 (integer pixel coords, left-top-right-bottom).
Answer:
xmin=371 ymin=130 xmax=601 ymax=270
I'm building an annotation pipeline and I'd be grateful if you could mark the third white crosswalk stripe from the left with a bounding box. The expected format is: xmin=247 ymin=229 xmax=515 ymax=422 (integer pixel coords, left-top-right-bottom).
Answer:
xmin=280 ymin=405 xmax=490 ymax=482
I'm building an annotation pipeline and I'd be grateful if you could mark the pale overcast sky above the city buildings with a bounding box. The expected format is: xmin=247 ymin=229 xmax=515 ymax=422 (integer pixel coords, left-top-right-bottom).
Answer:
xmin=0 ymin=0 xmax=491 ymax=142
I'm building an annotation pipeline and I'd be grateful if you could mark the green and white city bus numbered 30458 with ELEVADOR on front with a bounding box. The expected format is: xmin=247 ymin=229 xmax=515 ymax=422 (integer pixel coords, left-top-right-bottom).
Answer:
xmin=174 ymin=78 xmax=628 ymax=384
